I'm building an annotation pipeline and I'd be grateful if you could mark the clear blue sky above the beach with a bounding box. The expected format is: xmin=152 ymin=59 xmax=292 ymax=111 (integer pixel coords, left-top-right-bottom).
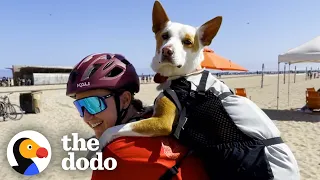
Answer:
xmin=0 ymin=0 xmax=320 ymax=74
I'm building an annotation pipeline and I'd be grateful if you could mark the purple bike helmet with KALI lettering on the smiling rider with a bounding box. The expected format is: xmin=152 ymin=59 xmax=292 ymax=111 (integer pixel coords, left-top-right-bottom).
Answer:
xmin=66 ymin=53 xmax=140 ymax=97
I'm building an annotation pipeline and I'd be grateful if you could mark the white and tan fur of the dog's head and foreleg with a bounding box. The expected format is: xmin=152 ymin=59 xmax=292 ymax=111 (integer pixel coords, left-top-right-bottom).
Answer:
xmin=103 ymin=1 xmax=222 ymax=141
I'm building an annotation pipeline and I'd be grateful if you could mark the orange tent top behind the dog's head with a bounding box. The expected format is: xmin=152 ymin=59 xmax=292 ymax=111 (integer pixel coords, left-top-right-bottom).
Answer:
xmin=201 ymin=48 xmax=248 ymax=71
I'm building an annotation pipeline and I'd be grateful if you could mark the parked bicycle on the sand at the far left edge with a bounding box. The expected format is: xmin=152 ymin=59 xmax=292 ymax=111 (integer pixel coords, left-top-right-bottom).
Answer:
xmin=0 ymin=92 xmax=24 ymax=121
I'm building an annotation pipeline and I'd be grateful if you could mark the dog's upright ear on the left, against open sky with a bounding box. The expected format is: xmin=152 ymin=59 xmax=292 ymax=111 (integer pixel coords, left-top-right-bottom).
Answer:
xmin=152 ymin=1 xmax=169 ymax=33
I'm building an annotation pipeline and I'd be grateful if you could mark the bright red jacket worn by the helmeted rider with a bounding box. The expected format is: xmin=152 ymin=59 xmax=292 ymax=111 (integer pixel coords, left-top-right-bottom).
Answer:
xmin=92 ymin=137 xmax=209 ymax=180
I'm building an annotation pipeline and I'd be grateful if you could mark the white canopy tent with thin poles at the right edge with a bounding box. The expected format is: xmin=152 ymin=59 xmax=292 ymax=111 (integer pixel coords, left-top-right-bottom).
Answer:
xmin=277 ymin=36 xmax=320 ymax=109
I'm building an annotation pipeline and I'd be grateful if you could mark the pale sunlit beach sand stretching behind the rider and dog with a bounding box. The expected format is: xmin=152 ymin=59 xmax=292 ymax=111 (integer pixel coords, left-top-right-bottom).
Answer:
xmin=0 ymin=75 xmax=320 ymax=180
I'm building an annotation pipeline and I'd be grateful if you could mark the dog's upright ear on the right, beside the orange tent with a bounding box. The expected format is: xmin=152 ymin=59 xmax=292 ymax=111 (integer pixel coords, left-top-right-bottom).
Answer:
xmin=199 ymin=16 xmax=222 ymax=46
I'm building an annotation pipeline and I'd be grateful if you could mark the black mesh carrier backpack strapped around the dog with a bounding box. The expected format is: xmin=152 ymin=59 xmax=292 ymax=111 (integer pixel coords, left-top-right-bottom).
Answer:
xmin=160 ymin=71 xmax=283 ymax=180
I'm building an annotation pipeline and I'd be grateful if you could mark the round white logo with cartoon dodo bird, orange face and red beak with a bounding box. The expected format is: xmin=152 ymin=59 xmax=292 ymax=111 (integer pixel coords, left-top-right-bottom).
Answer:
xmin=7 ymin=130 xmax=51 ymax=176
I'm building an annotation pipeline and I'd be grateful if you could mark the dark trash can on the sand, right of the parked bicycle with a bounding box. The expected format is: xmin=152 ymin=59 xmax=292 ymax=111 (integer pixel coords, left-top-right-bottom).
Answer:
xmin=19 ymin=91 xmax=42 ymax=114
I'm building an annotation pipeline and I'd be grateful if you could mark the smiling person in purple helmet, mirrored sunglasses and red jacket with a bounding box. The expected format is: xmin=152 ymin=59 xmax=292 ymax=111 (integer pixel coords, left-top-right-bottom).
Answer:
xmin=66 ymin=53 xmax=208 ymax=180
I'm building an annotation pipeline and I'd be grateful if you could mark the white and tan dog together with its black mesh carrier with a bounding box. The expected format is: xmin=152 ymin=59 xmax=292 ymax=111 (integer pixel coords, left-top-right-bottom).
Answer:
xmin=88 ymin=1 xmax=299 ymax=180
